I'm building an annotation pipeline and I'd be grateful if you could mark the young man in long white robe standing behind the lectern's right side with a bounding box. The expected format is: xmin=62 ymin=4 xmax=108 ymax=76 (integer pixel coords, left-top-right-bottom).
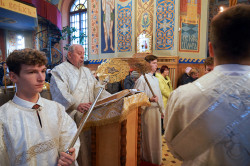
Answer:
xmin=134 ymin=55 xmax=164 ymax=165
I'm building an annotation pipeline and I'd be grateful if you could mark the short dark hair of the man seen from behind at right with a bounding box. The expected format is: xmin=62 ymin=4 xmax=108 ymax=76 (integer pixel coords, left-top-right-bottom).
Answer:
xmin=210 ymin=5 xmax=250 ymax=64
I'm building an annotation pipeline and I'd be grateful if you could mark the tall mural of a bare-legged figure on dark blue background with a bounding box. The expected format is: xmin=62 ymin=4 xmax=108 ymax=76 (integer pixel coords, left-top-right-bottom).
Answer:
xmin=101 ymin=0 xmax=115 ymax=53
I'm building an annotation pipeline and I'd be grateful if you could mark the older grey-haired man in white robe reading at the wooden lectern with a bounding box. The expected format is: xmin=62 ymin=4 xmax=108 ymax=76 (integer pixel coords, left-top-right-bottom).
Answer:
xmin=50 ymin=44 xmax=110 ymax=166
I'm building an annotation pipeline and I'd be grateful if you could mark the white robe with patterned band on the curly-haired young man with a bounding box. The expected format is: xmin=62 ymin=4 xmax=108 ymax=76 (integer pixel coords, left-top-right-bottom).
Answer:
xmin=0 ymin=96 xmax=80 ymax=166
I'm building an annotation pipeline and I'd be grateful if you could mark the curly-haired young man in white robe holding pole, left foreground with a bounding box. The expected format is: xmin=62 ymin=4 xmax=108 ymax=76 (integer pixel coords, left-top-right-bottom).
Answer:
xmin=0 ymin=48 xmax=80 ymax=166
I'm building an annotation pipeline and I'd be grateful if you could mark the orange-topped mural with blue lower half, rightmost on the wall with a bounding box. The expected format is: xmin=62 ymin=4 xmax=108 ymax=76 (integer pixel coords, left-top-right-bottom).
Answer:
xmin=179 ymin=0 xmax=201 ymax=52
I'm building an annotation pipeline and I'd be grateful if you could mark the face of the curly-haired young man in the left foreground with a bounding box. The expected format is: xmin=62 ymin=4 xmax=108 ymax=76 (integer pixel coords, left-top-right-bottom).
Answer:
xmin=10 ymin=64 xmax=46 ymax=98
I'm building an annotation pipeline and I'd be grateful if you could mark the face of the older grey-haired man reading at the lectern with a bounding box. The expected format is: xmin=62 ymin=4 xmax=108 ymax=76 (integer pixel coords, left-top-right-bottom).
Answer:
xmin=68 ymin=45 xmax=84 ymax=68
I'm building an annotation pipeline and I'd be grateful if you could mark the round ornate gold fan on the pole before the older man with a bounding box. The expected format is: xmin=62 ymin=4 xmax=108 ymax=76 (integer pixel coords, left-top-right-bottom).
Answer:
xmin=96 ymin=59 xmax=130 ymax=83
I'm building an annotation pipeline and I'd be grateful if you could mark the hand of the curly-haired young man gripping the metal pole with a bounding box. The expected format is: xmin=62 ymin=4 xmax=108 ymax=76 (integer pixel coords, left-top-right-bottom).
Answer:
xmin=57 ymin=148 xmax=76 ymax=166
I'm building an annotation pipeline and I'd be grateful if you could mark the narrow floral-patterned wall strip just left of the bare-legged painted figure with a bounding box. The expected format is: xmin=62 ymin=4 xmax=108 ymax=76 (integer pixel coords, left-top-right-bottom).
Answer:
xmin=90 ymin=0 xmax=99 ymax=55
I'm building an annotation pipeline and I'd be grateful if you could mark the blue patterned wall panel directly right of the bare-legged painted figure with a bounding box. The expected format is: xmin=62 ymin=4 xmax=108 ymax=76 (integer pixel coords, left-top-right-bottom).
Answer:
xmin=117 ymin=0 xmax=132 ymax=52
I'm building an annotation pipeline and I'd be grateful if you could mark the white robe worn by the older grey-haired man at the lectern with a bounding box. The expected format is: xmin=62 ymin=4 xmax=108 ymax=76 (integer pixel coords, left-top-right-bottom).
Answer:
xmin=50 ymin=61 xmax=110 ymax=118
